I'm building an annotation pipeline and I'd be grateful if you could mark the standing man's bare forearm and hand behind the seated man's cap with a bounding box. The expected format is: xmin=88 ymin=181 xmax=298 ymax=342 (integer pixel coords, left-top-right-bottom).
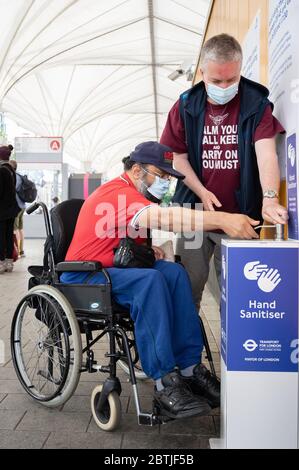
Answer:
xmin=173 ymin=153 xmax=222 ymax=211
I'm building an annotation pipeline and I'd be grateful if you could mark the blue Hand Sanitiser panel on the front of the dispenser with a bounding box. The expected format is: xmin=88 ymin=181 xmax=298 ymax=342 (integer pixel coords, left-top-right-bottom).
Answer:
xmin=222 ymin=244 xmax=298 ymax=372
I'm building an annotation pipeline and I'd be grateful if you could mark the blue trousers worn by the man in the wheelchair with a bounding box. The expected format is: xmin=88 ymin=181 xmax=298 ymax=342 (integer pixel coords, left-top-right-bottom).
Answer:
xmin=60 ymin=260 xmax=203 ymax=379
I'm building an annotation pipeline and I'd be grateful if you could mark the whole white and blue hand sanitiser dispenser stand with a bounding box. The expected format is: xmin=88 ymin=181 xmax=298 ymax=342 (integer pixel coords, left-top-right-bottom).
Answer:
xmin=210 ymin=237 xmax=299 ymax=449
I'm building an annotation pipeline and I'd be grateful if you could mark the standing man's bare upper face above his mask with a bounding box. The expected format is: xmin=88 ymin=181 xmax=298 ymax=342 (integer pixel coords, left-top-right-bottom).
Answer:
xmin=202 ymin=61 xmax=241 ymax=89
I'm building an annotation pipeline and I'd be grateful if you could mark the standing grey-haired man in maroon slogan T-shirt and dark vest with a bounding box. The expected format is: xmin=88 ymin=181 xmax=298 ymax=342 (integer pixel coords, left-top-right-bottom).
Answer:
xmin=161 ymin=34 xmax=288 ymax=306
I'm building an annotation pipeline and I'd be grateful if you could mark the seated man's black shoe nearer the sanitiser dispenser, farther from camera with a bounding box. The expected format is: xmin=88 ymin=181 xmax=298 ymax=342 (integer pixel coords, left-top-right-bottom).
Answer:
xmin=183 ymin=364 xmax=220 ymax=408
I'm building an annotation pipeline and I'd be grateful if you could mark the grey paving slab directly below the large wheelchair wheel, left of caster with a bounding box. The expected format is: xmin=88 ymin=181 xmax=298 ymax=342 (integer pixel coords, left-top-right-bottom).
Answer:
xmin=17 ymin=409 xmax=91 ymax=433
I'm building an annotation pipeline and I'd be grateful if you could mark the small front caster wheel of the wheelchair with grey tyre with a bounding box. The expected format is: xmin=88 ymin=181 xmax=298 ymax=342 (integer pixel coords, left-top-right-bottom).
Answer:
xmin=91 ymin=385 xmax=121 ymax=431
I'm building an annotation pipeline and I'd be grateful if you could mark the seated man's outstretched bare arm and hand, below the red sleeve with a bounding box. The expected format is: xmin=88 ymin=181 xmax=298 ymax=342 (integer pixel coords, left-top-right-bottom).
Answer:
xmin=136 ymin=205 xmax=259 ymax=240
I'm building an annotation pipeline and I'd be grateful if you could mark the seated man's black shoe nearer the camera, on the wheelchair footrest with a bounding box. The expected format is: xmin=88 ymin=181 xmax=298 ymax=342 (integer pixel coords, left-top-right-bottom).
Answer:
xmin=154 ymin=372 xmax=211 ymax=418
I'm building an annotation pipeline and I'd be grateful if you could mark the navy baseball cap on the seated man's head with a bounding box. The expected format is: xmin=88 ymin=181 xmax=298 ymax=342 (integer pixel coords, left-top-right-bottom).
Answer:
xmin=130 ymin=141 xmax=185 ymax=179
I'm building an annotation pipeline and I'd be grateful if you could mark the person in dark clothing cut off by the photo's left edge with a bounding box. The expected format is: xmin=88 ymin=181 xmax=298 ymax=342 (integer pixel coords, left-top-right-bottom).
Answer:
xmin=0 ymin=145 xmax=20 ymax=274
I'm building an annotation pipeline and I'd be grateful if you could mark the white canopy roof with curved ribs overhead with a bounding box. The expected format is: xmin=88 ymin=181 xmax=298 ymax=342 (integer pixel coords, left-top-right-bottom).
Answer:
xmin=0 ymin=0 xmax=210 ymax=174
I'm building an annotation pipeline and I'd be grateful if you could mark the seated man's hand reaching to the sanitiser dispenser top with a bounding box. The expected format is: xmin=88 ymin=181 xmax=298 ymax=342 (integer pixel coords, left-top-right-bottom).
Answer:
xmin=221 ymin=213 xmax=260 ymax=240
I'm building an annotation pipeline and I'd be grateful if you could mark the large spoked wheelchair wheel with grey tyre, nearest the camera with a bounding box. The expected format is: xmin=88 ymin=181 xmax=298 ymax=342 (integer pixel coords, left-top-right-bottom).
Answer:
xmin=11 ymin=285 xmax=82 ymax=408
